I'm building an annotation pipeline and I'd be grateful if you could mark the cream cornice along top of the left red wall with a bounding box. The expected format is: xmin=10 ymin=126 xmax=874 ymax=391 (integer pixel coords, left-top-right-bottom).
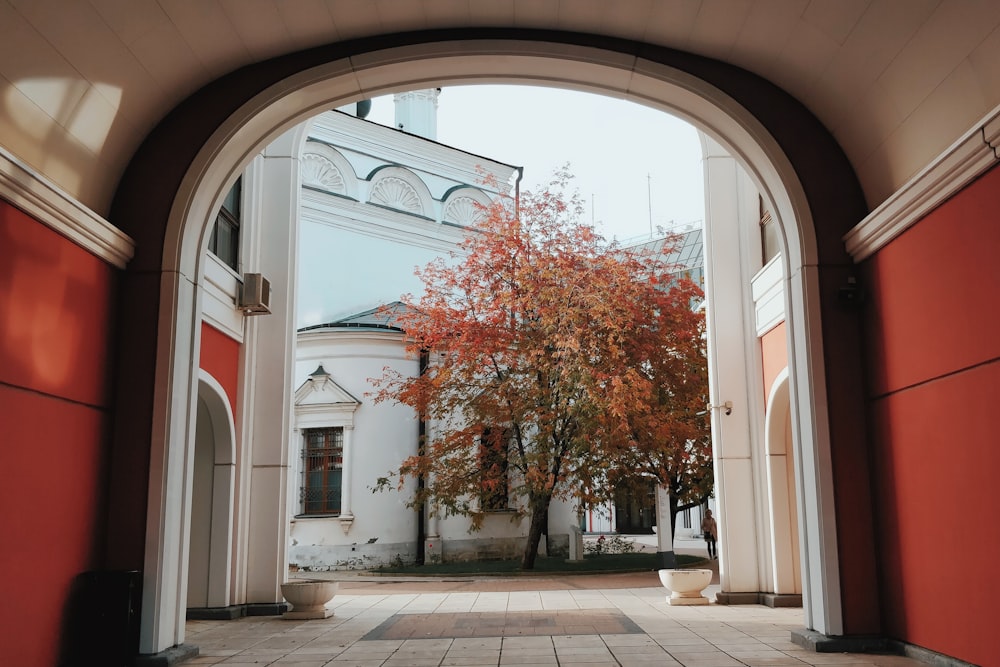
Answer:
xmin=0 ymin=147 xmax=135 ymax=269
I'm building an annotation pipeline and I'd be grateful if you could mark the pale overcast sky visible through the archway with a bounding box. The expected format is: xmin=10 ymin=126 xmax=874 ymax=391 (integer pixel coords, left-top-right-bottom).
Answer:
xmin=368 ymin=85 xmax=704 ymax=241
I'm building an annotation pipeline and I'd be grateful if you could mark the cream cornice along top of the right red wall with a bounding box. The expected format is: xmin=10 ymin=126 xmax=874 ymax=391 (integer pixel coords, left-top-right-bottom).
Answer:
xmin=844 ymin=107 xmax=1000 ymax=262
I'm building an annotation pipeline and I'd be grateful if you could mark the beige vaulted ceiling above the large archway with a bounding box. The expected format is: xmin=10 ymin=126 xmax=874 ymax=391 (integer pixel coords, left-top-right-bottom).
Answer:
xmin=0 ymin=0 xmax=1000 ymax=215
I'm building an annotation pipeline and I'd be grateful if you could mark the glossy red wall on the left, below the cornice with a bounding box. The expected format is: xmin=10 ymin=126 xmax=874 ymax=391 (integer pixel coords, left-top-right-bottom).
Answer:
xmin=0 ymin=200 xmax=117 ymax=667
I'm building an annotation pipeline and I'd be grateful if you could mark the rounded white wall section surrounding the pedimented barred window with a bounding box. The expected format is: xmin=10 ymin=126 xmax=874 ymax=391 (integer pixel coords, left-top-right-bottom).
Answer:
xmin=289 ymin=329 xmax=418 ymax=570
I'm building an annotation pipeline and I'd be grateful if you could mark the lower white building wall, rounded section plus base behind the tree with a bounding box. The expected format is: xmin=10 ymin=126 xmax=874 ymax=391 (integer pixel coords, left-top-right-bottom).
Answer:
xmin=289 ymin=324 xmax=575 ymax=571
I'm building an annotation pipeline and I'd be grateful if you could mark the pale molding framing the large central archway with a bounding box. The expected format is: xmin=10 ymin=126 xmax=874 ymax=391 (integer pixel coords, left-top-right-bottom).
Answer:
xmin=140 ymin=39 xmax=843 ymax=654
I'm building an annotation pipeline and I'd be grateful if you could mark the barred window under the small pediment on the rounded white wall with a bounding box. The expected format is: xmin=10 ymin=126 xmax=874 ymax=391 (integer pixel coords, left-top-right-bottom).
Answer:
xmin=301 ymin=426 xmax=344 ymax=514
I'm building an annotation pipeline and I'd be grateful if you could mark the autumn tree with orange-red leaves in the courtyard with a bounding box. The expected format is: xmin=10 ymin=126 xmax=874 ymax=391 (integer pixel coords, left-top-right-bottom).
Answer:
xmin=376 ymin=173 xmax=705 ymax=569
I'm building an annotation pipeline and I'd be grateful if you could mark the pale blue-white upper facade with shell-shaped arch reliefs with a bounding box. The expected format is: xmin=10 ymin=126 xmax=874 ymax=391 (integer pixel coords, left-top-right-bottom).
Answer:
xmin=296 ymin=102 xmax=516 ymax=328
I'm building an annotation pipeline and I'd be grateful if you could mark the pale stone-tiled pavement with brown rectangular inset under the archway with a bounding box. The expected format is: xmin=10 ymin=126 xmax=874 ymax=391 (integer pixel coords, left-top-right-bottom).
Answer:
xmin=185 ymin=540 xmax=923 ymax=667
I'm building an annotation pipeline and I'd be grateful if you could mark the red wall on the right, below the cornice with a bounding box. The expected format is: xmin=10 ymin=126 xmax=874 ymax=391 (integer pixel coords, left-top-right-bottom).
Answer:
xmin=865 ymin=163 xmax=1000 ymax=666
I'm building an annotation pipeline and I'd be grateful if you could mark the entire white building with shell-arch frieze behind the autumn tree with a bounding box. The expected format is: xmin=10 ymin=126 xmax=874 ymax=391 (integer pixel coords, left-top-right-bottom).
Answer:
xmin=287 ymin=96 xmax=577 ymax=571
